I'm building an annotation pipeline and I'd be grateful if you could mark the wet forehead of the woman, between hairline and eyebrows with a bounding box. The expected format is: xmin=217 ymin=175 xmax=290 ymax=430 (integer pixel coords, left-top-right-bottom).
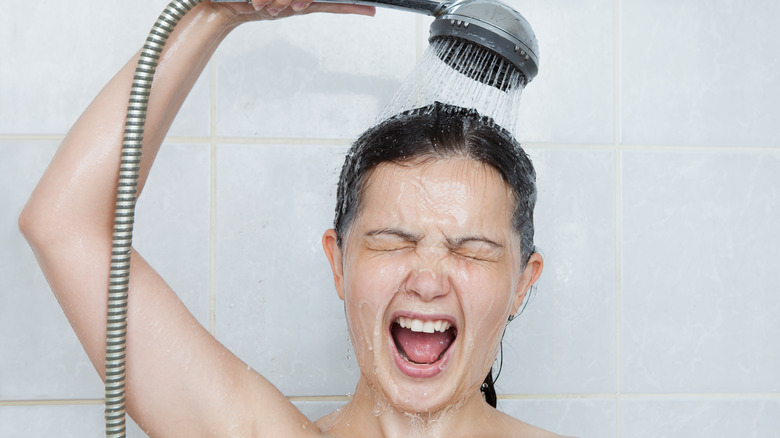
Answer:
xmin=358 ymin=158 xmax=514 ymax=231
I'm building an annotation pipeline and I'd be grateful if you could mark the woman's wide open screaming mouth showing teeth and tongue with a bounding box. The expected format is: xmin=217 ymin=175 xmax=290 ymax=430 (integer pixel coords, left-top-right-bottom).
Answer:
xmin=390 ymin=316 xmax=458 ymax=365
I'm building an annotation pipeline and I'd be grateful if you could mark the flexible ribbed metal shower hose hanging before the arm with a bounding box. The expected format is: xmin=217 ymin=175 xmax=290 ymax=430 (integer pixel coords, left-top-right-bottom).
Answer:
xmin=105 ymin=0 xmax=204 ymax=437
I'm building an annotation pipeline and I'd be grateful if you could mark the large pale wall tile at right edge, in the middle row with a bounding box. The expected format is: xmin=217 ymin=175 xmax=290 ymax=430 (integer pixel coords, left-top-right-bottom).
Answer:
xmin=622 ymin=151 xmax=780 ymax=393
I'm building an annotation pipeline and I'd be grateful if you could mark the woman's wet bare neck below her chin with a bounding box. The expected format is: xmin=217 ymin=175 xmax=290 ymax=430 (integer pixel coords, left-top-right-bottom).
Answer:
xmin=317 ymin=376 xmax=497 ymax=438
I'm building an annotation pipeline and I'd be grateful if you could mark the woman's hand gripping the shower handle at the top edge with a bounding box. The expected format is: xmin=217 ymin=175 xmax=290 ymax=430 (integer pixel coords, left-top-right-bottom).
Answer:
xmin=211 ymin=0 xmax=375 ymax=23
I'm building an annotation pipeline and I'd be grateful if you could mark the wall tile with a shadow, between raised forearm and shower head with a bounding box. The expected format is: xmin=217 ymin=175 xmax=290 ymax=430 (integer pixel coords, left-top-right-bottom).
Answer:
xmin=217 ymin=9 xmax=417 ymax=138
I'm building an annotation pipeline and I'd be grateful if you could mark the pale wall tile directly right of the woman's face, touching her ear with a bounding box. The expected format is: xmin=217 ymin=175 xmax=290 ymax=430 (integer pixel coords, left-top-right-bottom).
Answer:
xmin=494 ymin=149 xmax=617 ymax=394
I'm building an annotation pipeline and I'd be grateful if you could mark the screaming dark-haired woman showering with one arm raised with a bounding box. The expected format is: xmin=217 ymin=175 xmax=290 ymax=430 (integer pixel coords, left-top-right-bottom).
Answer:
xmin=19 ymin=0 xmax=555 ymax=437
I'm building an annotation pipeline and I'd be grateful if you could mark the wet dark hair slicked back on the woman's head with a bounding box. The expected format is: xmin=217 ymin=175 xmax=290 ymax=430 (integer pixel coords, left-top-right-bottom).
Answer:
xmin=333 ymin=102 xmax=536 ymax=407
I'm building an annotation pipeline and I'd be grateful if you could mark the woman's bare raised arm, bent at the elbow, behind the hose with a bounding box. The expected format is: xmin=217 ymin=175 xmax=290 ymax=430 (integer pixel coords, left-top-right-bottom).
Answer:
xmin=19 ymin=0 xmax=373 ymax=437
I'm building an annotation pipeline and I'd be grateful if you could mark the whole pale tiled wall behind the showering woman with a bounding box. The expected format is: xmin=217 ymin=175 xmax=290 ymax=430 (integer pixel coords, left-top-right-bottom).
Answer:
xmin=0 ymin=0 xmax=780 ymax=438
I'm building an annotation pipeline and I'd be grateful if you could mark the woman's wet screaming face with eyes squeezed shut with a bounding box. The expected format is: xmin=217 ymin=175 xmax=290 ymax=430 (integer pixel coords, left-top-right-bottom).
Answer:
xmin=323 ymin=159 xmax=541 ymax=412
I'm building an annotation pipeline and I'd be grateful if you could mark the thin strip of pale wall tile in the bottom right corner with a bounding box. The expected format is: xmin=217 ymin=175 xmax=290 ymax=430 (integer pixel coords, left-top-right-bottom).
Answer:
xmin=622 ymin=397 xmax=780 ymax=438
